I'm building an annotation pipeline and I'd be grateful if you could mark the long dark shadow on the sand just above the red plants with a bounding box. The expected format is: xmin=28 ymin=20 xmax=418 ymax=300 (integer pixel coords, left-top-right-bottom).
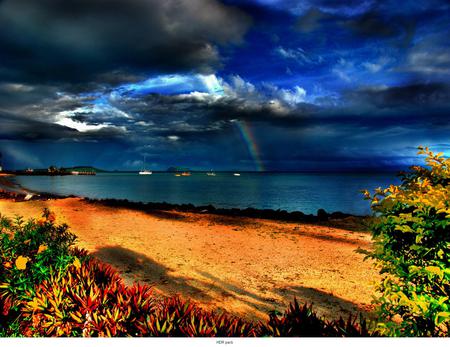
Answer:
xmin=93 ymin=246 xmax=370 ymax=318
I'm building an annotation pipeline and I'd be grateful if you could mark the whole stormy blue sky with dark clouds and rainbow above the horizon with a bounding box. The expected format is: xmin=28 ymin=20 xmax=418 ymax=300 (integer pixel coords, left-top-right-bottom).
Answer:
xmin=0 ymin=0 xmax=450 ymax=171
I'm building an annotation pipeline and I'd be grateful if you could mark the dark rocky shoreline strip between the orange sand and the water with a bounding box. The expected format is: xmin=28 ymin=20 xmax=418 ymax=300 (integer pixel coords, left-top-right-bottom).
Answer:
xmin=0 ymin=175 xmax=371 ymax=228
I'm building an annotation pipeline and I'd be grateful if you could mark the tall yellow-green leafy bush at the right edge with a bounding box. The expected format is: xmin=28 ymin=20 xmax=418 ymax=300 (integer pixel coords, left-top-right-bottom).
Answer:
xmin=365 ymin=147 xmax=450 ymax=336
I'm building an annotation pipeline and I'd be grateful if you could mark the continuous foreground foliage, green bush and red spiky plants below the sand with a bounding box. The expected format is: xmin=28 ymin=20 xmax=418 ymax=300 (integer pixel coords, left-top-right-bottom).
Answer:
xmin=0 ymin=210 xmax=371 ymax=337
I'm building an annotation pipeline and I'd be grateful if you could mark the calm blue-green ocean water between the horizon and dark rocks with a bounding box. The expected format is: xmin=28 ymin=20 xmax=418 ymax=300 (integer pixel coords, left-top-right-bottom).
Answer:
xmin=15 ymin=172 xmax=398 ymax=215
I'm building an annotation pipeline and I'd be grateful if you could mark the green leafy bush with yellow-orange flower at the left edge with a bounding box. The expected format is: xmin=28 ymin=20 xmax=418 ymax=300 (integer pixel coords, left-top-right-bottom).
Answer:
xmin=0 ymin=209 xmax=76 ymax=335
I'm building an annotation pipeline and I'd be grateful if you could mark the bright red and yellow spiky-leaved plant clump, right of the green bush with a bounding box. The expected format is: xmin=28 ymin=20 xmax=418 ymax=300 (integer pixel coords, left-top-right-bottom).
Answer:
xmin=21 ymin=259 xmax=153 ymax=336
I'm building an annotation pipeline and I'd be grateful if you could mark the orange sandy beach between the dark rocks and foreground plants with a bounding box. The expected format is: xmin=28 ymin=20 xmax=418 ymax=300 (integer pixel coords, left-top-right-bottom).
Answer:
xmin=0 ymin=194 xmax=379 ymax=319
